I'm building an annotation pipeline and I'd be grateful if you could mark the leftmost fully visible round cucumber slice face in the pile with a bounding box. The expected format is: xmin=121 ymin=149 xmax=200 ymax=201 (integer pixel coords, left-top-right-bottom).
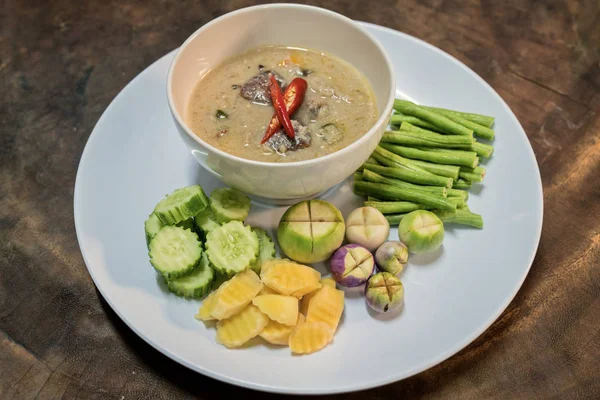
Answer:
xmin=148 ymin=225 xmax=202 ymax=280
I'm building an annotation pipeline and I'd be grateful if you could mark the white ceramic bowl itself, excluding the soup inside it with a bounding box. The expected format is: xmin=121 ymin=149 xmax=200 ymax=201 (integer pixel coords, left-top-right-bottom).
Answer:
xmin=167 ymin=4 xmax=396 ymax=204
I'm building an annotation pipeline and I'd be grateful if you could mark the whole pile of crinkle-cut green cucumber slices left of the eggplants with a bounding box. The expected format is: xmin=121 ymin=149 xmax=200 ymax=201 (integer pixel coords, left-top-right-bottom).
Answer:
xmin=144 ymin=185 xmax=284 ymax=298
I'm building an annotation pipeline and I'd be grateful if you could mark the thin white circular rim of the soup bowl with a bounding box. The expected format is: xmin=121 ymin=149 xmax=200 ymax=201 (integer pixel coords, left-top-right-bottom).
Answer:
xmin=166 ymin=3 xmax=396 ymax=168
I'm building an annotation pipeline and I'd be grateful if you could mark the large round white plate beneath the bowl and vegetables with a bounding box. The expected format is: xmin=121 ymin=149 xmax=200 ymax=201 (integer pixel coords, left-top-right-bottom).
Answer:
xmin=74 ymin=23 xmax=543 ymax=394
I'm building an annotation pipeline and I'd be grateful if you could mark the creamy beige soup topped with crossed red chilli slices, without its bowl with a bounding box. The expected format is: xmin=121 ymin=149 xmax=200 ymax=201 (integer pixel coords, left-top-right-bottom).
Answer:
xmin=187 ymin=46 xmax=378 ymax=162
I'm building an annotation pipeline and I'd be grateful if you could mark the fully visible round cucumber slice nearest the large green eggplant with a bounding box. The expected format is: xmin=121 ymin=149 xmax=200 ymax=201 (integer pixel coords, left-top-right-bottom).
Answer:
xmin=205 ymin=221 xmax=258 ymax=276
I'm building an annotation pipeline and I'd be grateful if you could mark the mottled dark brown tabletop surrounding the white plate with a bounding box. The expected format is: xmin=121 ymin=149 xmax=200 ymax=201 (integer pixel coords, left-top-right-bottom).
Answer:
xmin=0 ymin=0 xmax=600 ymax=399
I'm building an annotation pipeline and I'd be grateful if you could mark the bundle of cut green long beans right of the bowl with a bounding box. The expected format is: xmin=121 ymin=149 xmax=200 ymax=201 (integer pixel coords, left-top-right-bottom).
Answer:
xmin=354 ymin=99 xmax=495 ymax=228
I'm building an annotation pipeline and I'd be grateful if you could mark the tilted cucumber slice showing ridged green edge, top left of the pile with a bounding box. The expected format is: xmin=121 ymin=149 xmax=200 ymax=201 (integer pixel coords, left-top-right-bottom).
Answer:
xmin=154 ymin=185 xmax=208 ymax=225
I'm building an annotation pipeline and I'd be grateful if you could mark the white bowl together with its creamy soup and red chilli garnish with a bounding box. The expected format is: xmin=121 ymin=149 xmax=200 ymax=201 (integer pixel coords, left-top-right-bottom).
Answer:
xmin=165 ymin=4 xmax=396 ymax=204
